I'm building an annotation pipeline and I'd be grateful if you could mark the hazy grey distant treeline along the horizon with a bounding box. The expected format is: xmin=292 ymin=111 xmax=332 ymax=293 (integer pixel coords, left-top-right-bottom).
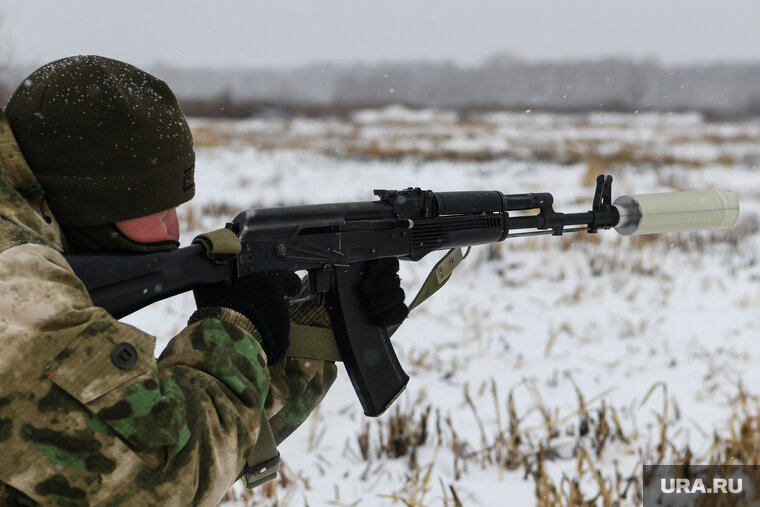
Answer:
xmin=0 ymin=57 xmax=760 ymax=118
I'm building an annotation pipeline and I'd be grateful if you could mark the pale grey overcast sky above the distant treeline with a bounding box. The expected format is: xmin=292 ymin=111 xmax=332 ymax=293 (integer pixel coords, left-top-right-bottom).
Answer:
xmin=0 ymin=0 xmax=760 ymax=67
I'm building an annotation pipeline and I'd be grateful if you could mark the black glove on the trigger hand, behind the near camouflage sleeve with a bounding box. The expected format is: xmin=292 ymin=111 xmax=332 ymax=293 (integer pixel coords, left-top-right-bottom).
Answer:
xmin=193 ymin=271 xmax=301 ymax=365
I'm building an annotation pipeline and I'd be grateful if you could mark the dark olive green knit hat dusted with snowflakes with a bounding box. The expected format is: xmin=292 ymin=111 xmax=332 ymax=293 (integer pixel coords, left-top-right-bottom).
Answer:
xmin=5 ymin=56 xmax=195 ymax=227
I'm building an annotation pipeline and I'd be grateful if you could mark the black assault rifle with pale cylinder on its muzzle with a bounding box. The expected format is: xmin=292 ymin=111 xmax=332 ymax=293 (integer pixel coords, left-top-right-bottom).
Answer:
xmin=66 ymin=176 xmax=739 ymax=416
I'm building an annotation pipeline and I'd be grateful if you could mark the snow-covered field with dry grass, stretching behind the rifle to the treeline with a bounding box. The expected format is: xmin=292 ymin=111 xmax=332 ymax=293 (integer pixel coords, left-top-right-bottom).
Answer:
xmin=121 ymin=107 xmax=760 ymax=506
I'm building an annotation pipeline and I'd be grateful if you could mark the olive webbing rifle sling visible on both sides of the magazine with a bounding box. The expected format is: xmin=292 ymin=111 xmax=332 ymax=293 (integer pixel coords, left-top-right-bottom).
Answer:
xmin=286 ymin=248 xmax=469 ymax=361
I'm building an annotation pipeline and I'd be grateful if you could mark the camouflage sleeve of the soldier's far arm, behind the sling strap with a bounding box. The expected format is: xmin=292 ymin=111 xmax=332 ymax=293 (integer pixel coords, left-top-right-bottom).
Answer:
xmin=265 ymin=294 xmax=337 ymax=445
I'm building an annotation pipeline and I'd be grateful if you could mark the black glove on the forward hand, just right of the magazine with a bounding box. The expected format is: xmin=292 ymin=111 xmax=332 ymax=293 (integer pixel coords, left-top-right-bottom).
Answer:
xmin=359 ymin=257 xmax=409 ymax=327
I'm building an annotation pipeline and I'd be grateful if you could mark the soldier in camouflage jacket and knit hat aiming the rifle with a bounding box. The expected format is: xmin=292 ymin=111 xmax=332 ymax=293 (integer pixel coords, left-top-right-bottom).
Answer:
xmin=0 ymin=56 xmax=407 ymax=505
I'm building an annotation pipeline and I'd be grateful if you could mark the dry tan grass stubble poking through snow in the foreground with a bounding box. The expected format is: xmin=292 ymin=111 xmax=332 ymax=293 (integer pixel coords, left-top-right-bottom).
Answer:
xmin=220 ymin=378 xmax=760 ymax=507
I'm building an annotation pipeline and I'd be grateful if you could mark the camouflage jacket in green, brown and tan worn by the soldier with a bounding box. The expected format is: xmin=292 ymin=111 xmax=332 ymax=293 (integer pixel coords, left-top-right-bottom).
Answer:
xmin=0 ymin=110 xmax=336 ymax=506
